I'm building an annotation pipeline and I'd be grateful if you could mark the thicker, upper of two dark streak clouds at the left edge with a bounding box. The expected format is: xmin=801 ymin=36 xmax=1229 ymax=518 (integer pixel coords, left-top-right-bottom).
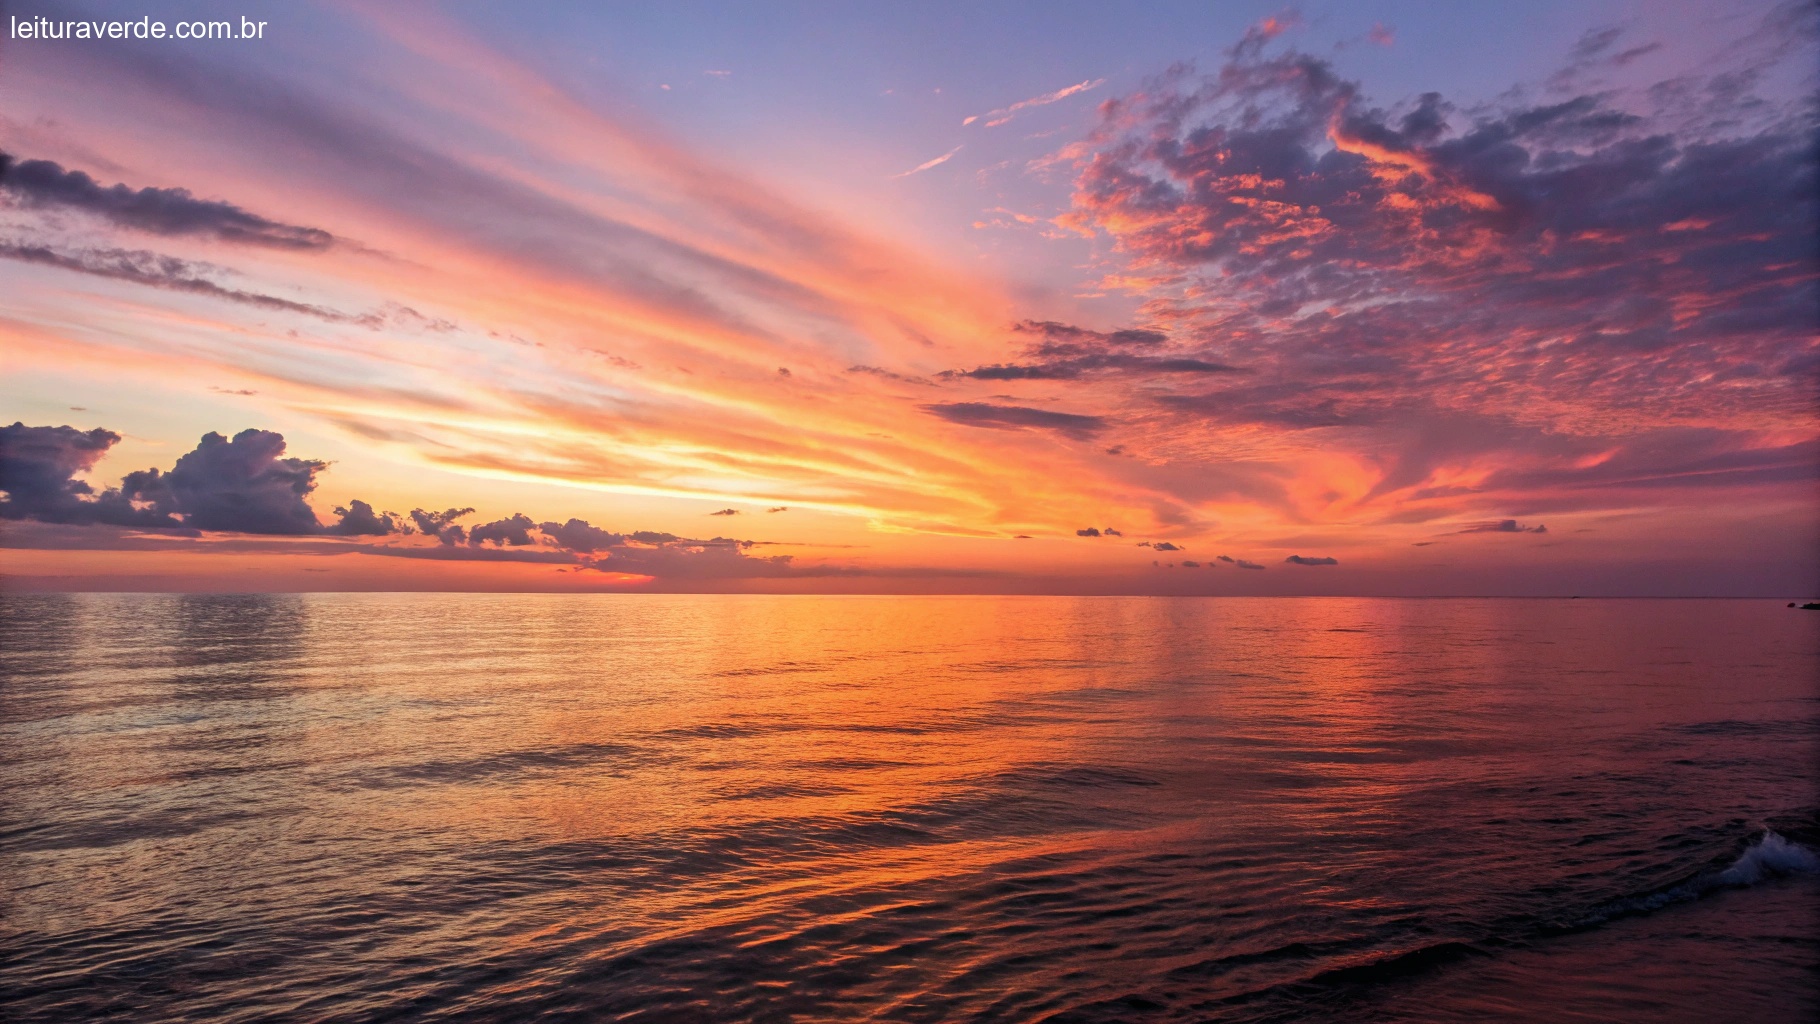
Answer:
xmin=0 ymin=153 xmax=335 ymax=249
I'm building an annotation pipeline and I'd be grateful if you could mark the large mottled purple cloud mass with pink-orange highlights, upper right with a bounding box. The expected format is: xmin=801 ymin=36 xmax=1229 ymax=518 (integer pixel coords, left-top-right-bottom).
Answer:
xmin=1055 ymin=20 xmax=1820 ymax=502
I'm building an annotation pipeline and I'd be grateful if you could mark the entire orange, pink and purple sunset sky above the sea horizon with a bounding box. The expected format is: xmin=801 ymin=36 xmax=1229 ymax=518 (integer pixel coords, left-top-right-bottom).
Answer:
xmin=0 ymin=2 xmax=1820 ymax=598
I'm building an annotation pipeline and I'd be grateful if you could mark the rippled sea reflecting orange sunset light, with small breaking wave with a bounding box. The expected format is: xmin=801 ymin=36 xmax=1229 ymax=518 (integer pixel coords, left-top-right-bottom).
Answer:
xmin=0 ymin=595 xmax=1820 ymax=1024
